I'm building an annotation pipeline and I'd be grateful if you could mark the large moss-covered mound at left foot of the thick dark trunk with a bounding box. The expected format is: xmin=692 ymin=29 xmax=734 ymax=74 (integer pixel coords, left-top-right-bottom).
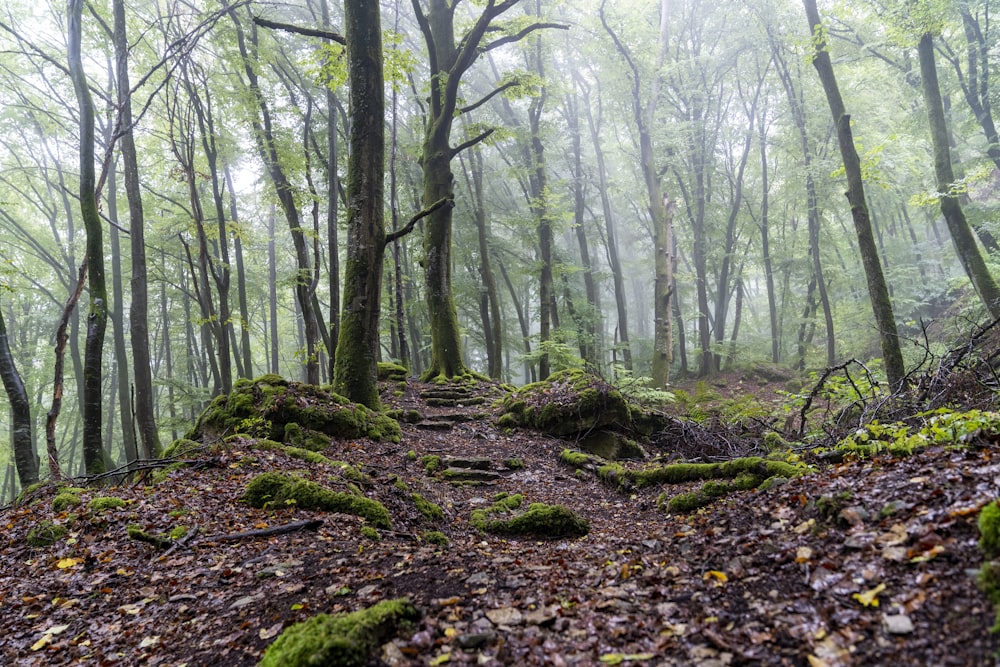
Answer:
xmin=186 ymin=375 xmax=402 ymax=446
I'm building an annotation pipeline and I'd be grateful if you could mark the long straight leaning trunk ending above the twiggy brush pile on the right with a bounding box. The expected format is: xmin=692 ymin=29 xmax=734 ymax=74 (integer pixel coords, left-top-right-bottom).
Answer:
xmin=803 ymin=0 xmax=906 ymax=389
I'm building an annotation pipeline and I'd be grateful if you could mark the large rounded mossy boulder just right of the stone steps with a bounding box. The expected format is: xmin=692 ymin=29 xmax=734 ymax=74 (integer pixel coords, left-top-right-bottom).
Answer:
xmin=497 ymin=369 xmax=632 ymax=437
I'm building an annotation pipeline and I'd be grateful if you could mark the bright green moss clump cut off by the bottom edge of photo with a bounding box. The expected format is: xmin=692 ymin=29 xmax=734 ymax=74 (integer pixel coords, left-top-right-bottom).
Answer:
xmin=260 ymin=599 xmax=420 ymax=667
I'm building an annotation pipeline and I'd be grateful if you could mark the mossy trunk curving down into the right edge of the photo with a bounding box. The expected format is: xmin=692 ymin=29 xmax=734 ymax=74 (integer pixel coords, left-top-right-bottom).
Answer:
xmin=917 ymin=33 xmax=1000 ymax=318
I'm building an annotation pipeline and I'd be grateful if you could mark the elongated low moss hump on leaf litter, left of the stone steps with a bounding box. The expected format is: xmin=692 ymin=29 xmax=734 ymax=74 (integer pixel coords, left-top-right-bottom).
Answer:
xmin=243 ymin=472 xmax=392 ymax=528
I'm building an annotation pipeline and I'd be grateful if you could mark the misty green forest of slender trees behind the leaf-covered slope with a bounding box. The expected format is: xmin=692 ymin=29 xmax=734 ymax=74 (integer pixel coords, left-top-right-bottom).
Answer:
xmin=0 ymin=0 xmax=1000 ymax=490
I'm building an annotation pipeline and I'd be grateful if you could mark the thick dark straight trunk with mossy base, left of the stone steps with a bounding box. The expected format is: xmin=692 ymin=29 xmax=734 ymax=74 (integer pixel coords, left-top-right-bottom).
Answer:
xmin=333 ymin=0 xmax=385 ymax=410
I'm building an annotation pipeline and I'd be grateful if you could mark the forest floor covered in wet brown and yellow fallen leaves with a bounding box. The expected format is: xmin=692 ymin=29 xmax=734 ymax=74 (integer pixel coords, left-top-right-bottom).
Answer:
xmin=0 ymin=381 xmax=1000 ymax=667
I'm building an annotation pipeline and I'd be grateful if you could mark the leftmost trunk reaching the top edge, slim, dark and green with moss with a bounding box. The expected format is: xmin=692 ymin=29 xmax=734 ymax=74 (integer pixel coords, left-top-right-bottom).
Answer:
xmin=68 ymin=0 xmax=108 ymax=475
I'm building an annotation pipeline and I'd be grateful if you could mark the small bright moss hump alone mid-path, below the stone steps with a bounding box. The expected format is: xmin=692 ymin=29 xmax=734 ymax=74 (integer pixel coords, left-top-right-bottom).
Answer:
xmin=469 ymin=493 xmax=590 ymax=539
